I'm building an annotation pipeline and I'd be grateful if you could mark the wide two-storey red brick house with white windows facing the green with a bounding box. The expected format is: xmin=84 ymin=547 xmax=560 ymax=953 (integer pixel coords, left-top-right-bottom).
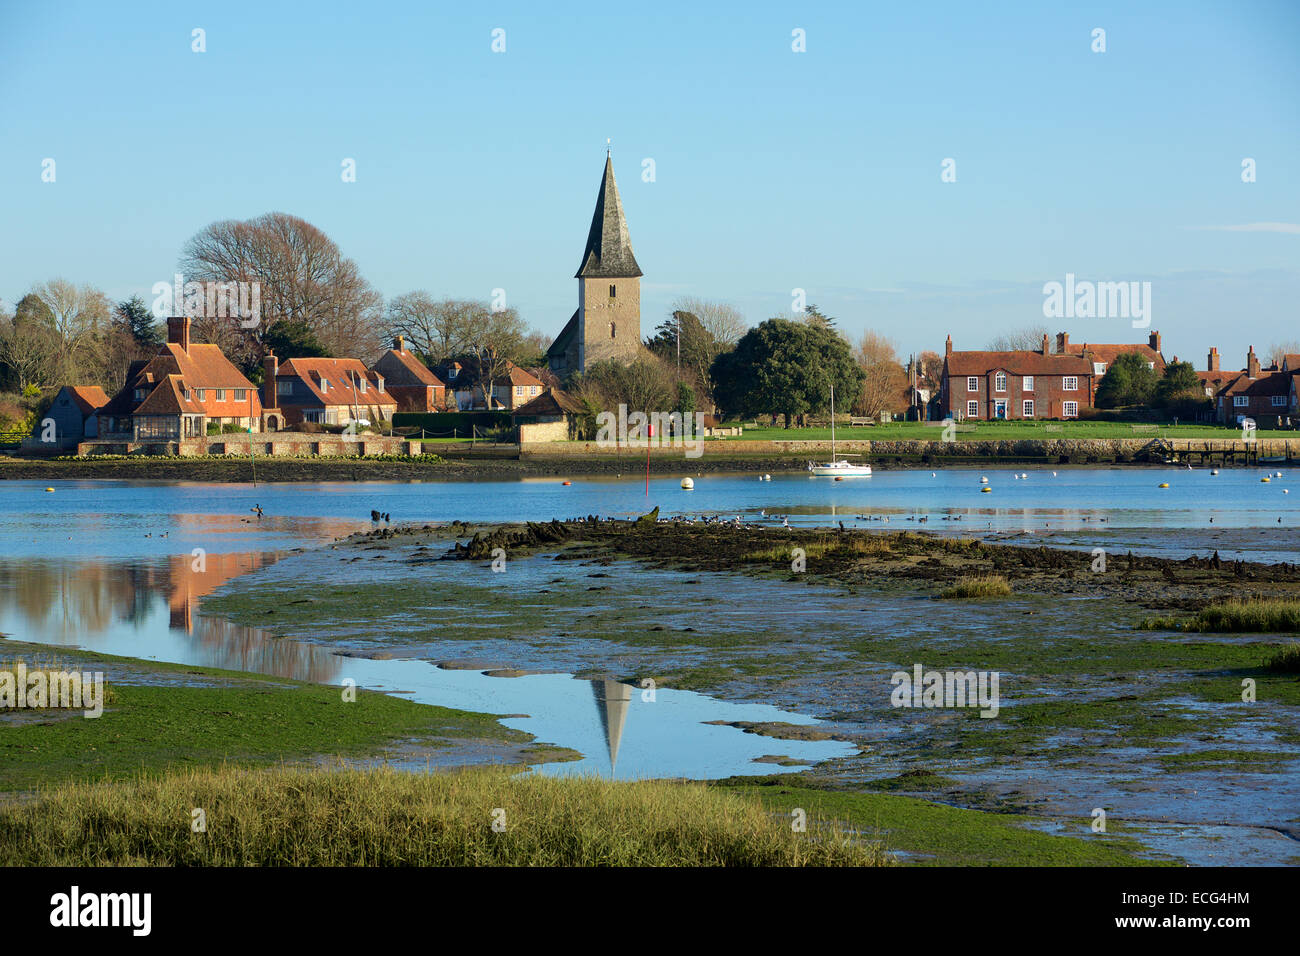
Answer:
xmin=940 ymin=336 xmax=1100 ymax=421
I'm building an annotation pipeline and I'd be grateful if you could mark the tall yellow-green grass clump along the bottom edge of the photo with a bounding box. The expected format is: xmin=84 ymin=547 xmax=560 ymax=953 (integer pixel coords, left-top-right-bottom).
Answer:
xmin=0 ymin=766 xmax=892 ymax=866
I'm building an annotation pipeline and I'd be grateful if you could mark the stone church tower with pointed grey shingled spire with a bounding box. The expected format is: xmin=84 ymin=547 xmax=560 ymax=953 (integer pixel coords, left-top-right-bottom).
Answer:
xmin=546 ymin=155 xmax=641 ymax=378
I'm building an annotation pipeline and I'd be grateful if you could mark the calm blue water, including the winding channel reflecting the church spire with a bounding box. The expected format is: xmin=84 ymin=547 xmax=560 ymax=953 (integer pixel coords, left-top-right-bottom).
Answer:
xmin=0 ymin=468 xmax=1300 ymax=778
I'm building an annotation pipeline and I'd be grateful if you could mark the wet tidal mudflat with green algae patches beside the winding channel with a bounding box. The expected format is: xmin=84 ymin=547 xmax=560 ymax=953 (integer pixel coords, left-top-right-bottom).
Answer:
xmin=203 ymin=522 xmax=1300 ymax=864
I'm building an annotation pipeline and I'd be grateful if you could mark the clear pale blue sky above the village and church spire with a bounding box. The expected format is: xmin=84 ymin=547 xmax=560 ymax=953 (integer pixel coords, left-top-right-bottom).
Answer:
xmin=0 ymin=0 xmax=1300 ymax=367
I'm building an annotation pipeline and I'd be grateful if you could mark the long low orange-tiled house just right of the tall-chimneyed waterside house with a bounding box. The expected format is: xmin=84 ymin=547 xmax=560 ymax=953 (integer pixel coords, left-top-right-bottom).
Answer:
xmin=261 ymin=354 xmax=398 ymax=432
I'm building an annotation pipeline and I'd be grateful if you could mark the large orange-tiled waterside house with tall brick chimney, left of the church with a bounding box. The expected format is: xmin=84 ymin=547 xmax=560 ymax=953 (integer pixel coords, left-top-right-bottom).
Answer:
xmin=98 ymin=316 xmax=261 ymax=442
